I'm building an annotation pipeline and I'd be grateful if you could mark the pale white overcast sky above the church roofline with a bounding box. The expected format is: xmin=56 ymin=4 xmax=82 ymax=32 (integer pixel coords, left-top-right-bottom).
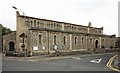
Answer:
xmin=0 ymin=0 xmax=119 ymax=35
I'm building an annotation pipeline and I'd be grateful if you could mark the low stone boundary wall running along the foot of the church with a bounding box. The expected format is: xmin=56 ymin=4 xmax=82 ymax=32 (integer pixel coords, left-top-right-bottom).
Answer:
xmin=3 ymin=48 xmax=118 ymax=57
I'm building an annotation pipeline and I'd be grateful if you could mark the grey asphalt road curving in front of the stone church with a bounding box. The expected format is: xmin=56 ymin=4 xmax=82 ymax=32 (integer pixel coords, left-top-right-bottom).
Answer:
xmin=2 ymin=53 xmax=116 ymax=71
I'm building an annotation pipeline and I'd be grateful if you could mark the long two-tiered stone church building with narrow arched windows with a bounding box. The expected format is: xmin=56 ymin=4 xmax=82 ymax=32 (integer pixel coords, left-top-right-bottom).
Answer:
xmin=16 ymin=12 xmax=116 ymax=55
